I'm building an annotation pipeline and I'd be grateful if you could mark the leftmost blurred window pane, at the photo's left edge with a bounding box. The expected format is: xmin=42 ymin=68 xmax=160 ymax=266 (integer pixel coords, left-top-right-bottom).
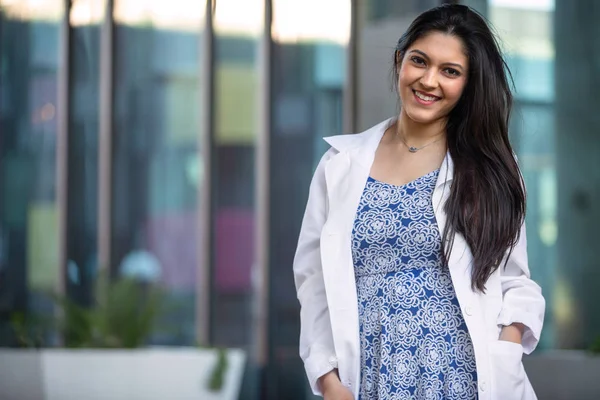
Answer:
xmin=0 ymin=0 xmax=64 ymax=345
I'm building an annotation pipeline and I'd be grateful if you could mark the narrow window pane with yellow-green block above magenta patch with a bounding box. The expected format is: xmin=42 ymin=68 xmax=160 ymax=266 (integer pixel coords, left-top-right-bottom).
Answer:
xmin=211 ymin=0 xmax=264 ymax=348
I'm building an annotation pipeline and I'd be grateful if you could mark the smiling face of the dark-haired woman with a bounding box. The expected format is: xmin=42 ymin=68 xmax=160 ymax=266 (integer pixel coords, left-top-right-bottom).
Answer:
xmin=398 ymin=32 xmax=469 ymax=124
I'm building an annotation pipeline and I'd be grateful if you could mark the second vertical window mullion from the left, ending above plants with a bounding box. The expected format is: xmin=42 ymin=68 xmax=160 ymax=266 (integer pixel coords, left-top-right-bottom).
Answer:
xmin=98 ymin=0 xmax=114 ymax=271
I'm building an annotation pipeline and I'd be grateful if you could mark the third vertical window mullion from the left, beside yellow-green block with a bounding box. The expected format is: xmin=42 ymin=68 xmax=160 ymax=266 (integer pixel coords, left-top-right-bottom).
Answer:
xmin=196 ymin=0 xmax=215 ymax=345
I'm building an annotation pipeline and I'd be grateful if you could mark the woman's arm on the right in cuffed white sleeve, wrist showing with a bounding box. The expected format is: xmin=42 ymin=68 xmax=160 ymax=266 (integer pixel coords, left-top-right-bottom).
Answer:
xmin=498 ymin=224 xmax=546 ymax=354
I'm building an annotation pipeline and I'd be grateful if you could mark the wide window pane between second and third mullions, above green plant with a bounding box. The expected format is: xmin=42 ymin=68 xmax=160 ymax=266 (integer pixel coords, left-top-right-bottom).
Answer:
xmin=111 ymin=0 xmax=205 ymax=344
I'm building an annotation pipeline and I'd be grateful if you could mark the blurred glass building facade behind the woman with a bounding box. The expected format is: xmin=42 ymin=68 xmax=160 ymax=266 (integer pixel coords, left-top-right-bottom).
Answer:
xmin=0 ymin=0 xmax=600 ymax=399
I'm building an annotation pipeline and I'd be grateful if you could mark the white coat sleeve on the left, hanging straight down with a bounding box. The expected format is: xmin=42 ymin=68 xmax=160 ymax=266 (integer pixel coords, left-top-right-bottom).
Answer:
xmin=293 ymin=149 xmax=337 ymax=395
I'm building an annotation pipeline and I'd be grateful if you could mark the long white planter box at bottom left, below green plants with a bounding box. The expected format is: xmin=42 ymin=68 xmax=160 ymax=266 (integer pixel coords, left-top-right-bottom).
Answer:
xmin=0 ymin=348 xmax=246 ymax=400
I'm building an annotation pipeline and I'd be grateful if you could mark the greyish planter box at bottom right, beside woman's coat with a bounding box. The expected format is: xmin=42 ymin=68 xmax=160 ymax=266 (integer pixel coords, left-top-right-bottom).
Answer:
xmin=523 ymin=350 xmax=600 ymax=400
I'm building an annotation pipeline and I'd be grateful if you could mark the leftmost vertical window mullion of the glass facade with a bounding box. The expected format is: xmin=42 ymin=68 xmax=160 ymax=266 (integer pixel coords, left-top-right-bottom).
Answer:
xmin=56 ymin=0 xmax=71 ymax=295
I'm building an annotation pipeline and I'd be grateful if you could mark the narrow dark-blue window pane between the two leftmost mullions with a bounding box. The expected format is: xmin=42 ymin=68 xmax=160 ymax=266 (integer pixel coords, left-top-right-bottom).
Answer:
xmin=67 ymin=0 xmax=104 ymax=304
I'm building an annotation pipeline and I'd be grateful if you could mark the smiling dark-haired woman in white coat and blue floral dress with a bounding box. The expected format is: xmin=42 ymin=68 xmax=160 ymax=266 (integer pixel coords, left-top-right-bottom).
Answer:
xmin=294 ymin=5 xmax=545 ymax=400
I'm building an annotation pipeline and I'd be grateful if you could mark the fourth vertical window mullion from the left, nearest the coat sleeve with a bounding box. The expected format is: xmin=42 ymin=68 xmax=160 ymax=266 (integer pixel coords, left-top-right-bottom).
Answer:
xmin=253 ymin=0 xmax=272 ymax=367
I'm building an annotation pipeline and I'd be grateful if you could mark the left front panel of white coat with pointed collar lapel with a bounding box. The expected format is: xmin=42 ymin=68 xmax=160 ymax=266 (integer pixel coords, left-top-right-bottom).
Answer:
xmin=321 ymin=120 xmax=390 ymax=395
